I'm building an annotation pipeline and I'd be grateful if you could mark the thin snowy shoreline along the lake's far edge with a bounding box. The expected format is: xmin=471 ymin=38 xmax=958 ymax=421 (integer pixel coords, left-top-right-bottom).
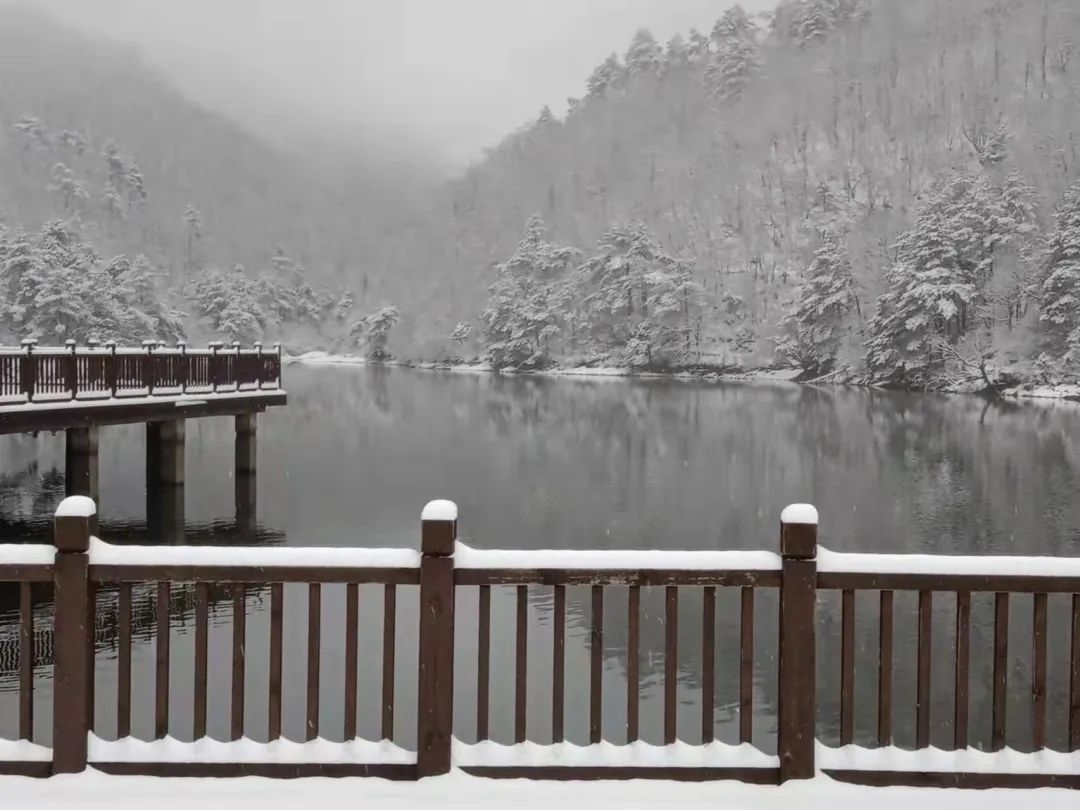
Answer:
xmin=284 ymin=351 xmax=1080 ymax=404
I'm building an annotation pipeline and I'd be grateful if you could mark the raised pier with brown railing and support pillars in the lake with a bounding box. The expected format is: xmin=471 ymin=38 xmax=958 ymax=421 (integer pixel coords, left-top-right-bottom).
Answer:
xmin=0 ymin=340 xmax=286 ymax=514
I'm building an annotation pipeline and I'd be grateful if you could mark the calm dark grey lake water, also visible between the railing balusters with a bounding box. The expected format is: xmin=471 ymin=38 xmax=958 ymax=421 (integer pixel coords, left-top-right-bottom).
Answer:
xmin=0 ymin=365 xmax=1080 ymax=751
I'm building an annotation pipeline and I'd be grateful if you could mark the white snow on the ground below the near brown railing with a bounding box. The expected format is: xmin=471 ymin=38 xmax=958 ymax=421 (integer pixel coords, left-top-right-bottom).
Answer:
xmin=0 ymin=771 xmax=1077 ymax=810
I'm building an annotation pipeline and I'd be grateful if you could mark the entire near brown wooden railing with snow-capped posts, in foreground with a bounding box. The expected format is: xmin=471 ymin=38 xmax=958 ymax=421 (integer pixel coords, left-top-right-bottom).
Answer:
xmin=0 ymin=498 xmax=1080 ymax=787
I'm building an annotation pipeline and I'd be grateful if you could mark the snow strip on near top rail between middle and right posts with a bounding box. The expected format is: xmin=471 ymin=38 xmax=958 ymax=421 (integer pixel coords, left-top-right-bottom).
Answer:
xmin=454 ymin=542 xmax=781 ymax=571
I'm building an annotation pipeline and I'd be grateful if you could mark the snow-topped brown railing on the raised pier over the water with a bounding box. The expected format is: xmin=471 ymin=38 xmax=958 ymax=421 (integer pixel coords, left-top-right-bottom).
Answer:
xmin=0 ymin=341 xmax=281 ymax=403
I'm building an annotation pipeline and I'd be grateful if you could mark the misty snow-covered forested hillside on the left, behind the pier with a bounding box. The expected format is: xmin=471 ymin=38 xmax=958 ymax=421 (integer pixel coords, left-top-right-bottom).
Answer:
xmin=0 ymin=5 xmax=406 ymax=346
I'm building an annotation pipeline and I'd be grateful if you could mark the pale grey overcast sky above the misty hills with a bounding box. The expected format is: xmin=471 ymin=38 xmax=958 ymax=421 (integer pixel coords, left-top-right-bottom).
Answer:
xmin=31 ymin=0 xmax=774 ymax=168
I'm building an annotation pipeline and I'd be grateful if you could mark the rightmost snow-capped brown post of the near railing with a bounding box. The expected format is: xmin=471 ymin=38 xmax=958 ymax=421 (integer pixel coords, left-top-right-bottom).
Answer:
xmin=777 ymin=503 xmax=818 ymax=782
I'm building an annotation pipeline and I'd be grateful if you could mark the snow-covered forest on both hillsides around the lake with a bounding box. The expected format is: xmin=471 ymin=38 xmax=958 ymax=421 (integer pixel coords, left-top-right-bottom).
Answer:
xmin=6 ymin=0 xmax=1080 ymax=388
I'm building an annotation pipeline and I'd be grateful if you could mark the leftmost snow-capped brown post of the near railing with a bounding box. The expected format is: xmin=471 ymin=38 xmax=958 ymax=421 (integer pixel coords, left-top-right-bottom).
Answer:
xmin=53 ymin=496 xmax=97 ymax=773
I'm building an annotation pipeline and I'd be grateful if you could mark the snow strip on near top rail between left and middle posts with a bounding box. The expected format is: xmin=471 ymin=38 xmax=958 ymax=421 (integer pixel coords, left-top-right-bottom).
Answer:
xmin=90 ymin=537 xmax=420 ymax=568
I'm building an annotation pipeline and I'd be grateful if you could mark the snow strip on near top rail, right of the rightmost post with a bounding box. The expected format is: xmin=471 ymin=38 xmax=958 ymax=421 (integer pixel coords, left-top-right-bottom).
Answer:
xmin=818 ymin=546 xmax=1080 ymax=577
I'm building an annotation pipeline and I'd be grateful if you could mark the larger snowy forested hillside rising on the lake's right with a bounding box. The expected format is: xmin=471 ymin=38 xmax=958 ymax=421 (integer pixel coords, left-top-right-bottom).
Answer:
xmin=378 ymin=0 xmax=1080 ymax=384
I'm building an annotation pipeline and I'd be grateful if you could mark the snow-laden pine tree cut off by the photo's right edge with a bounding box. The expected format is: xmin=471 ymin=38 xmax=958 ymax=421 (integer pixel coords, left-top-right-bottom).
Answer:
xmin=1039 ymin=185 xmax=1080 ymax=363
